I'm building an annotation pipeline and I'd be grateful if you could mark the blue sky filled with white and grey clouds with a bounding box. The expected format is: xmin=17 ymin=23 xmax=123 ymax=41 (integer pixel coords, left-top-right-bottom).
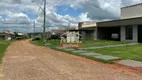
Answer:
xmin=0 ymin=0 xmax=142 ymax=32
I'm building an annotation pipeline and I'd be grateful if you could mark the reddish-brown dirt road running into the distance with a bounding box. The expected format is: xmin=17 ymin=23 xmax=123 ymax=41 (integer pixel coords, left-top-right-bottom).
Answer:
xmin=2 ymin=41 xmax=142 ymax=80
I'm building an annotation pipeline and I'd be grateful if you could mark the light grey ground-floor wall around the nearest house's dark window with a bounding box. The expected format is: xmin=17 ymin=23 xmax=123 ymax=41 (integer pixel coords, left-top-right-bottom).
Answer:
xmin=120 ymin=25 xmax=138 ymax=42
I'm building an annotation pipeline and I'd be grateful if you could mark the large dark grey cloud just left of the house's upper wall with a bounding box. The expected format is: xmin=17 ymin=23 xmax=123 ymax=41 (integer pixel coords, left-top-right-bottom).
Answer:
xmin=72 ymin=0 xmax=121 ymax=21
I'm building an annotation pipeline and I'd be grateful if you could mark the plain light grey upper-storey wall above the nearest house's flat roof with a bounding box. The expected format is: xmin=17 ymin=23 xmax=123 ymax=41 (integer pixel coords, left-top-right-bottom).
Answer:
xmin=121 ymin=4 xmax=142 ymax=19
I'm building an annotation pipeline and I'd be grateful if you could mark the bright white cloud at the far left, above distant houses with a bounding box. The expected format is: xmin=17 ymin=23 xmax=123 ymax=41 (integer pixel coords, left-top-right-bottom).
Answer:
xmin=0 ymin=12 xmax=33 ymax=32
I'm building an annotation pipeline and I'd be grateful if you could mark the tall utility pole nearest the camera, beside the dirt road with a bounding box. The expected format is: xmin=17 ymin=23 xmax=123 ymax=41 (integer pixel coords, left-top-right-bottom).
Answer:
xmin=43 ymin=0 xmax=46 ymax=42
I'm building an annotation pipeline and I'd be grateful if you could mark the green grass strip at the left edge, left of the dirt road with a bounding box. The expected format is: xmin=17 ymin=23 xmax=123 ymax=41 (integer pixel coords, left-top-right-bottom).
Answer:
xmin=0 ymin=40 xmax=13 ymax=63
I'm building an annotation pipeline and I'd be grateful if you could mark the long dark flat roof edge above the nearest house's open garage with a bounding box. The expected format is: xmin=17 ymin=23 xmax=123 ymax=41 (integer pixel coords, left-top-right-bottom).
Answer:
xmin=97 ymin=17 xmax=142 ymax=27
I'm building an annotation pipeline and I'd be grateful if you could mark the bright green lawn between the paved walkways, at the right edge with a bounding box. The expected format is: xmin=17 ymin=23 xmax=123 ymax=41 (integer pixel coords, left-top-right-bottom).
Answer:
xmin=85 ymin=44 xmax=142 ymax=61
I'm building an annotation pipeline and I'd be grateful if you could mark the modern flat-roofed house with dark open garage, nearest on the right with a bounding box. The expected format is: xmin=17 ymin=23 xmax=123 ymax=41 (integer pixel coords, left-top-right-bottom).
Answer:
xmin=79 ymin=3 xmax=142 ymax=42
